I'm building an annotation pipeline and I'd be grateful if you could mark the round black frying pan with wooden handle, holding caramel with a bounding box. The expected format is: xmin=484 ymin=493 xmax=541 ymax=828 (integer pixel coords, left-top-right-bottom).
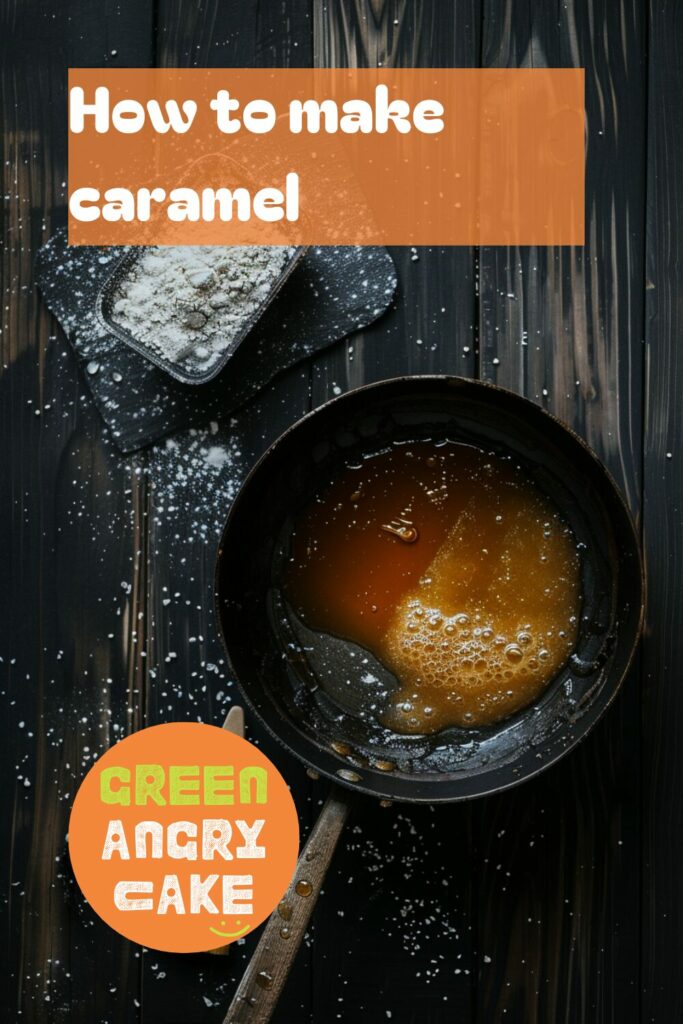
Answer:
xmin=216 ymin=377 xmax=644 ymax=1024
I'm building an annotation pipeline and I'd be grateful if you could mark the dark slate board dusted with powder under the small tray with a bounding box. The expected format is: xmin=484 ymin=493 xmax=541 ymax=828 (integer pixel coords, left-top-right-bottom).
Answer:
xmin=36 ymin=230 xmax=396 ymax=453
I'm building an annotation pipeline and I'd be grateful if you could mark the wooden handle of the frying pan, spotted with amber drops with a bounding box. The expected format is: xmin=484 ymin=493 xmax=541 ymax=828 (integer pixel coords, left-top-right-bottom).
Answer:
xmin=223 ymin=788 xmax=349 ymax=1024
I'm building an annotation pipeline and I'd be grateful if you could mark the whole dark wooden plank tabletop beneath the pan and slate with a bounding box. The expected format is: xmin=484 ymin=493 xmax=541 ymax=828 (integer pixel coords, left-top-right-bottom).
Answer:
xmin=0 ymin=0 xmax=683 ymax=1024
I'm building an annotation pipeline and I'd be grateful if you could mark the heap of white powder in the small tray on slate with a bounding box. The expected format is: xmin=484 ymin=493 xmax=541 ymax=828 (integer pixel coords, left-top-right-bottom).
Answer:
xmin=110 ymin=246 xmax=294 ymax=375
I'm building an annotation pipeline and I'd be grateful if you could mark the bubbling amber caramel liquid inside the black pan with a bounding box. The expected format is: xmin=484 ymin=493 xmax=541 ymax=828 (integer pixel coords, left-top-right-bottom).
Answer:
xmin=285 ymin=441 xmax=581 ymax=733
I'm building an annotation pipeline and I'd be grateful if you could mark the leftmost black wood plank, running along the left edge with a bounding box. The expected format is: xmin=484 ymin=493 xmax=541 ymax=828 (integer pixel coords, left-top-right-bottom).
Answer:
xmin=0 ymin=0 xmax=156 ymax=1024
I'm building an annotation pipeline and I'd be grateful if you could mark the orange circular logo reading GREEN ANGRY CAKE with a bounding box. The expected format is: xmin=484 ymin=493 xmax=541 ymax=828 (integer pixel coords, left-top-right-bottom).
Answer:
xmin=69 ymin=722 xmax=299 ymax=952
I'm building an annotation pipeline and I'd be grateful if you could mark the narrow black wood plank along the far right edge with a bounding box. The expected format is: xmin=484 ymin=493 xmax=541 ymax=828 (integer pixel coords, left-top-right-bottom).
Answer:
xmin=641 ymin=0 xmax=683 ymax=1024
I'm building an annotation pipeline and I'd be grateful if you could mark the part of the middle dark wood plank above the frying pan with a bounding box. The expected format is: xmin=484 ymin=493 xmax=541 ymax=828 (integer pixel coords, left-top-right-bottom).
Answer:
xmin=311 ymin=0 xmax=480 ymax=407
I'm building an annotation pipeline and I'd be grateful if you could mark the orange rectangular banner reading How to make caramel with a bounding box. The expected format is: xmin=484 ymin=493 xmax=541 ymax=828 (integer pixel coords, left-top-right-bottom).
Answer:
xmin=69 ymin=69 xmax=585 ymax=246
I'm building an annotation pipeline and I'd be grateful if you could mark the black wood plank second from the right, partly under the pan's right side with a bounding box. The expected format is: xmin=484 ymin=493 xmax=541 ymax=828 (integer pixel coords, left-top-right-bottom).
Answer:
xmin=477 ymin=0 xmax=646 ymax=1024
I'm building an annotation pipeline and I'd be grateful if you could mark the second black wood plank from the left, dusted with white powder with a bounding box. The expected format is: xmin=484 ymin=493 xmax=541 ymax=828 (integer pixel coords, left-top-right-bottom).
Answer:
xmin=142 ymin=0 xmax=318 ymax=1024
